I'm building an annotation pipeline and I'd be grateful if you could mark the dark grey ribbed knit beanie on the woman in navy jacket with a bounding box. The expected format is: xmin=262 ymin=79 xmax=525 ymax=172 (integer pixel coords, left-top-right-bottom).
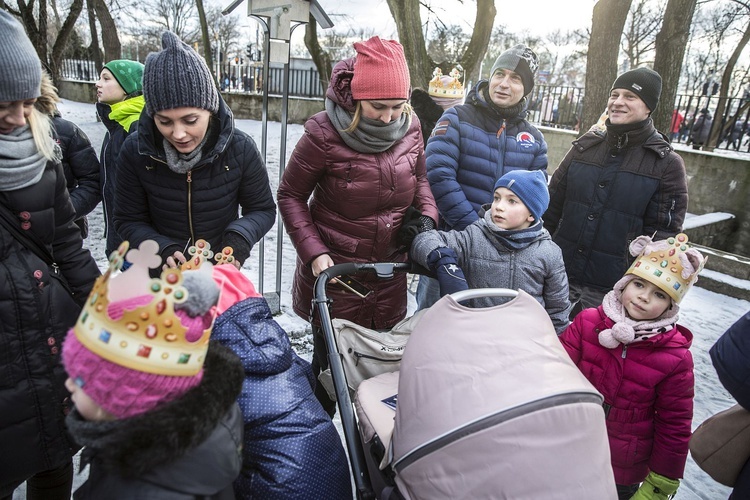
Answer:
xmin=143 ymin=31 xmax=219 ymax=116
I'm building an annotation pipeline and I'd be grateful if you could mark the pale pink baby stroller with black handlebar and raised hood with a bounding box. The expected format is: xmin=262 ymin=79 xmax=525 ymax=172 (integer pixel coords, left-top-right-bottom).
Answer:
xmin=314 ymin=263 xmax=617 ymax=499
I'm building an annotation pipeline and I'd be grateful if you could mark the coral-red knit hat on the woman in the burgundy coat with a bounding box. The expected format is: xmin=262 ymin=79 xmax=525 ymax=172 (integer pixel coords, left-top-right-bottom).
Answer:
xmin=351 ymin=36 xmax=411 ymax=101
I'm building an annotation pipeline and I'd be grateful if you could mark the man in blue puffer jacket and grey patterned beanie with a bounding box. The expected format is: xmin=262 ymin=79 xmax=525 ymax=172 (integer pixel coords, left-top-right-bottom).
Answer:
xmin=417 ymin=44 xmax=547 ymax=309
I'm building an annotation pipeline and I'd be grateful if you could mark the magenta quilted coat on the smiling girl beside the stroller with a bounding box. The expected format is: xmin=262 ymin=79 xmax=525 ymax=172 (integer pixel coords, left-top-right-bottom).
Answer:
xmin=560 ymin=306 xmax=694 ymax=485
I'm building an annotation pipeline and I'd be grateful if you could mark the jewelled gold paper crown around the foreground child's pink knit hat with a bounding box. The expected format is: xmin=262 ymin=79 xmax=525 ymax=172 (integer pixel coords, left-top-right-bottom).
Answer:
xmin=74 ymin=240 xmax=213 ymax=377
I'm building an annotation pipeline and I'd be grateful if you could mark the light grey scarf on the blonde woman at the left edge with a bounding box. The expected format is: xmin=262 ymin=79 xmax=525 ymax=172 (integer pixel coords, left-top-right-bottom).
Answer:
xmin=0 ymin=125 xmax=47 ymax=191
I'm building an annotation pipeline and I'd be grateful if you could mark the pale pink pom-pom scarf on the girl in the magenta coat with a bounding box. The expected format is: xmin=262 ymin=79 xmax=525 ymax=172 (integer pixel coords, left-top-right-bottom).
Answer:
xmin=599 ymin=290 xmax=680 ymax=349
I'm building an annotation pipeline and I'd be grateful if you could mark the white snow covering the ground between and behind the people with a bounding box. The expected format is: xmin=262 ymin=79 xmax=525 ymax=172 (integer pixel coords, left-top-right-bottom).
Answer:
xmin=14 ymin=100 xmax=750 ymax=500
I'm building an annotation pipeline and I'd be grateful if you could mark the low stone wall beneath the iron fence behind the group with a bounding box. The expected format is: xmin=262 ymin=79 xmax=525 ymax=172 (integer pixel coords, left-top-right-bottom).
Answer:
xmin=59 ymin=81 xmax=750 ymax=256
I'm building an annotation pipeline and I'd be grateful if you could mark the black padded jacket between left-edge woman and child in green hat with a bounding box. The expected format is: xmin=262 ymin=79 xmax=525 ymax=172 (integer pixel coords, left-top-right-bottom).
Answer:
xmin=52 ymin=113 xmax=102 ymax=227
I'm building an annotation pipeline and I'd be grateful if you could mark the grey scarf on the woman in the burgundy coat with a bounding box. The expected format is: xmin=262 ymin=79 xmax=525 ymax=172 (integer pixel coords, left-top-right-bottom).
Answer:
xmin=326 ymin=98 xmax=411 ymax=153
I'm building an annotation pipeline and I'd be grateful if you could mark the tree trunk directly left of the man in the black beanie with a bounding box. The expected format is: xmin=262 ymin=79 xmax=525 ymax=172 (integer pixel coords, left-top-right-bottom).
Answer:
xmin=580 ymin=0 xmax=632 ymax=133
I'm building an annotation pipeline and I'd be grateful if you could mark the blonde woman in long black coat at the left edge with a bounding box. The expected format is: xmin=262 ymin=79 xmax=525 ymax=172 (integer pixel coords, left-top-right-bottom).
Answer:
xmin=0 ymin=10 xmax=99 ymax=500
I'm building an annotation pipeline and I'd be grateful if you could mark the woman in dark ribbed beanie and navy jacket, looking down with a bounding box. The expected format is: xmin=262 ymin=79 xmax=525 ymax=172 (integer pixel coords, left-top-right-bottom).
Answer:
xmin=115 ymin=31 xmax=276 ymax=274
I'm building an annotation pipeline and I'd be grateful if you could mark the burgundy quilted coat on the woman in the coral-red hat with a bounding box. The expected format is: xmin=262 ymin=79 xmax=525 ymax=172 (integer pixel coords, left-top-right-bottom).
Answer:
xmin=278 ymin=59 xmax=438 ymax=328
